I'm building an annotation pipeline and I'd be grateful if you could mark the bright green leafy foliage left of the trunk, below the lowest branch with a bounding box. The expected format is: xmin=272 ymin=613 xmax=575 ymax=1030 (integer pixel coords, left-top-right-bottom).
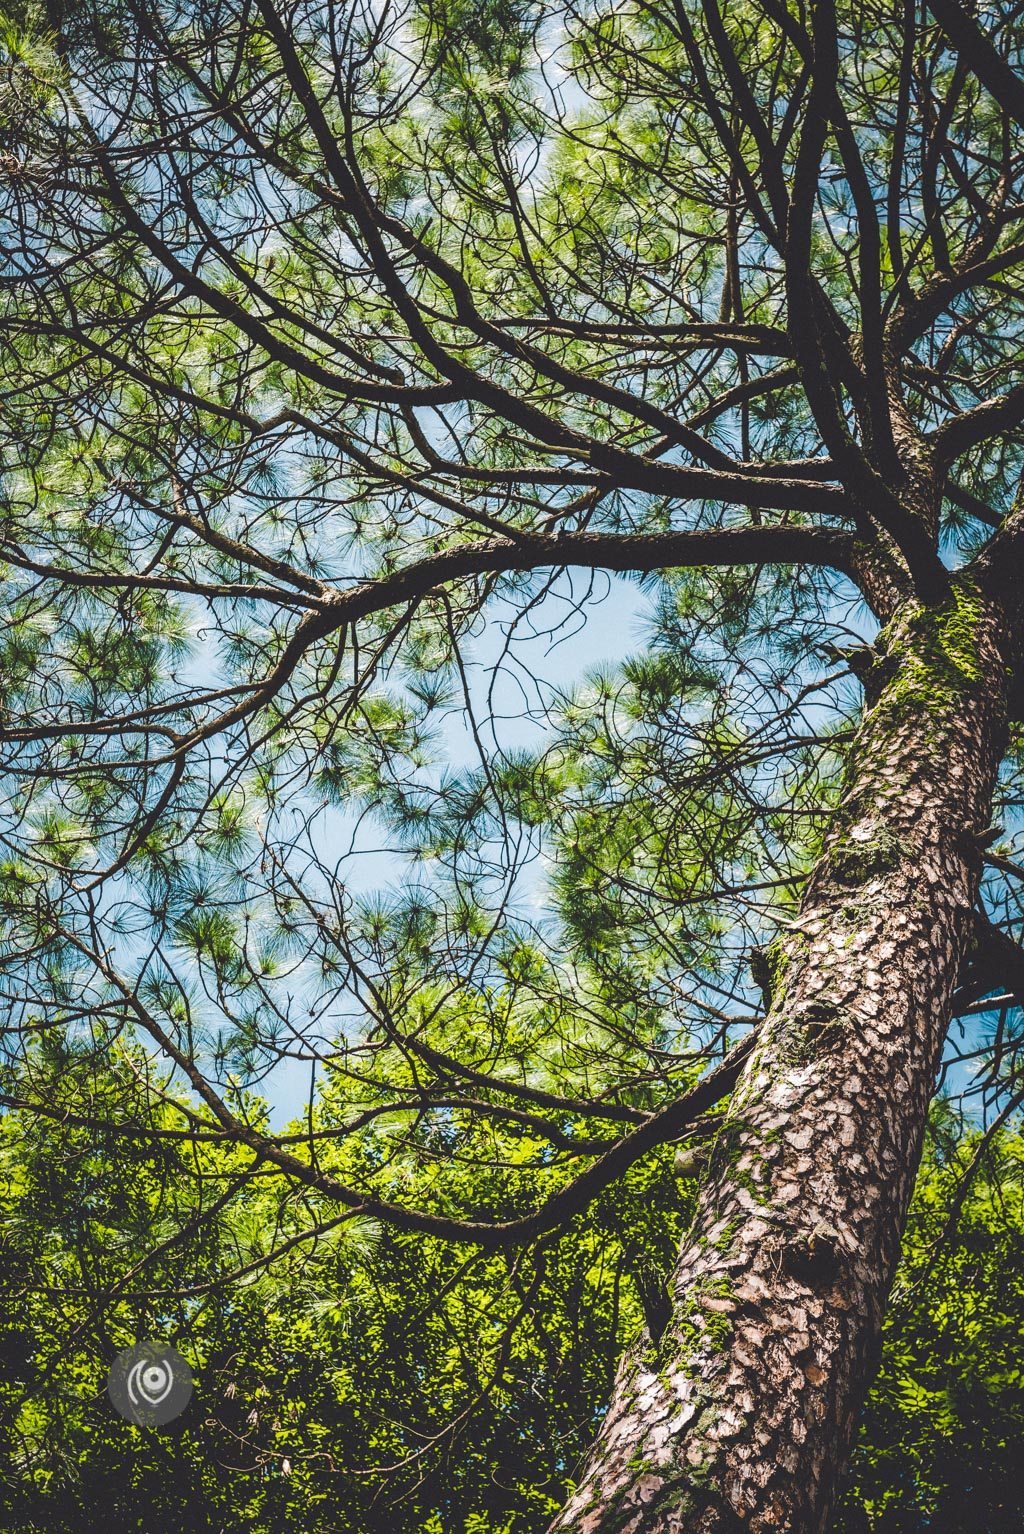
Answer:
xmin=0 ymin=1060 xmax=684 ymax=1534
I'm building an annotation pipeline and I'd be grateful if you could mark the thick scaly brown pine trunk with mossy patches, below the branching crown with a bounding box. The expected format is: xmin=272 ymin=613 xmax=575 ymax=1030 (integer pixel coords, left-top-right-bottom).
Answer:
xmin=552 ymin=583 xmax=1007 ymax=1534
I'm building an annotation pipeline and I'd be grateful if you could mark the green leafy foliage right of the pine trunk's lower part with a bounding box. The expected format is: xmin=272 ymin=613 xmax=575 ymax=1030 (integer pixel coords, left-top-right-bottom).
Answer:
xmin=835 ymin=1116 xmax=1024 ymax=1534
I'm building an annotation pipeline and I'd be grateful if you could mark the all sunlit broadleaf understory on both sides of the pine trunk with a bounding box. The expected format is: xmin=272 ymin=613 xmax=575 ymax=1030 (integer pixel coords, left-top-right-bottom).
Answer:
xmin=0 ymin=1081 xmax=1024 ymax=1534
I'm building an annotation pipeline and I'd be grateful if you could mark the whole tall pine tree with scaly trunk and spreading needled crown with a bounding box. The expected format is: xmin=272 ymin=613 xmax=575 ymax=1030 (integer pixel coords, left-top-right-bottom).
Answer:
xmin=0 ymin=0 xmax=1024 ymax=1534
